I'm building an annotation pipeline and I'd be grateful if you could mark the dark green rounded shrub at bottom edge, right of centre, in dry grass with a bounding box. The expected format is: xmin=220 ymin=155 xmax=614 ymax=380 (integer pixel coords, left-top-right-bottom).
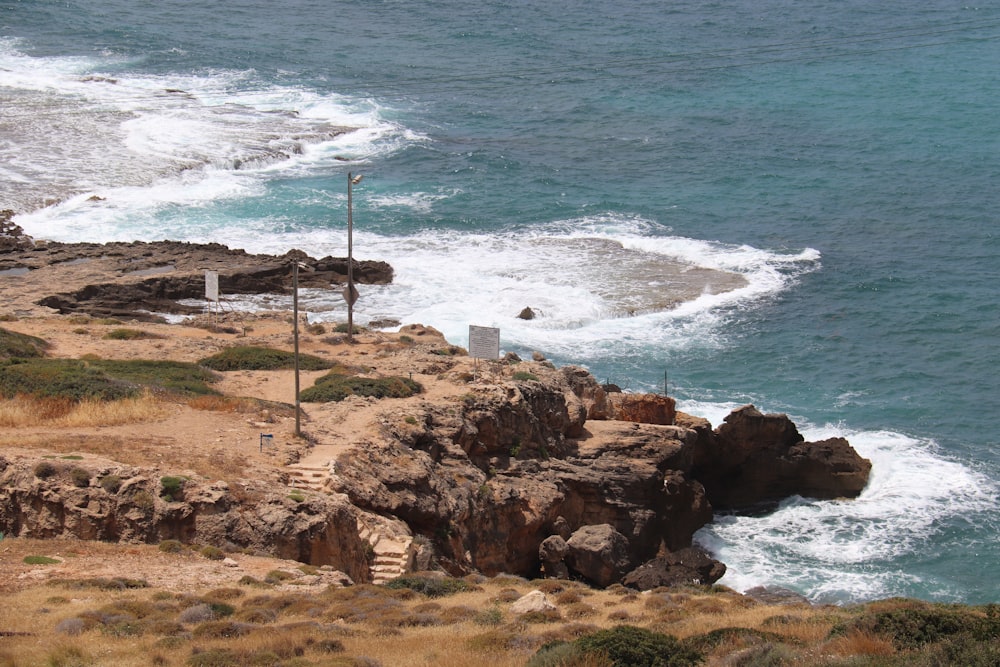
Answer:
xmin=573 ymin=625 xmax=702 ymax=667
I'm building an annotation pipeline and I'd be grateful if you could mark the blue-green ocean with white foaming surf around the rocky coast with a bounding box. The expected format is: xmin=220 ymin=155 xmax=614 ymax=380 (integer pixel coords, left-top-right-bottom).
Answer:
xmin=0 ymin=0 xmax=1000 ymax=603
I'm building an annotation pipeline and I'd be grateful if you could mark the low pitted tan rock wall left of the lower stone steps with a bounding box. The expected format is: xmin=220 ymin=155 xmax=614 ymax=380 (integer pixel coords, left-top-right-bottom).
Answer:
xmin=0 ymin=459 xmax=370 ymax=582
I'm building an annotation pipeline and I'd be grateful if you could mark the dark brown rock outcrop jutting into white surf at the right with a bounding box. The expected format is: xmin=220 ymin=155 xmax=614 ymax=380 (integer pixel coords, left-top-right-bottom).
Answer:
xmin=692 ymin=405 xmax=871 ymax=509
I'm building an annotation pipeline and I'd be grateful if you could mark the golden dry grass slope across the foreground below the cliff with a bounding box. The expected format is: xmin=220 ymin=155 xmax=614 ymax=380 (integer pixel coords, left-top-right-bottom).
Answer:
xmin=0 ymin=539 xmax=984 ymax=667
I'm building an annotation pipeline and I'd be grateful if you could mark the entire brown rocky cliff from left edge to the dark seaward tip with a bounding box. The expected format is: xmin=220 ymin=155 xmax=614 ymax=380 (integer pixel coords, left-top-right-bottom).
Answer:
xmin=0 ymin=357 xmax=870 ymax=588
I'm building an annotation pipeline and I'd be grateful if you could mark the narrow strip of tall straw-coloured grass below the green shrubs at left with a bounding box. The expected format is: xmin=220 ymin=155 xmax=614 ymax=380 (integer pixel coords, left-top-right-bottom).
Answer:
xmin=0 ymin=393 xmax=167 ymax=428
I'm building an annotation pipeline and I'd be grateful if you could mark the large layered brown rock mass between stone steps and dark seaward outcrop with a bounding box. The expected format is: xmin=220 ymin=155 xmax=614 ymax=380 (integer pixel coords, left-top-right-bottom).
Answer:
xmin=336 ymin=376 xmax=711 ymax=576
